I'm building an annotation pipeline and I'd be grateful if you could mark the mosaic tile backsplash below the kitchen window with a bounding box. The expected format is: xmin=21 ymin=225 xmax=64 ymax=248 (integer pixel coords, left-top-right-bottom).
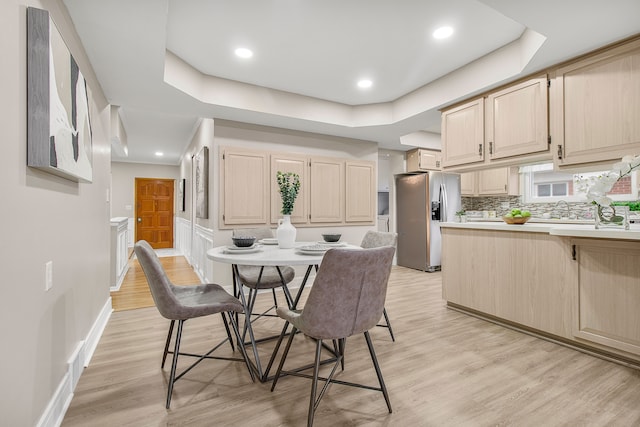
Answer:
xmin=462 ymin=196 xmax=593 ymax=219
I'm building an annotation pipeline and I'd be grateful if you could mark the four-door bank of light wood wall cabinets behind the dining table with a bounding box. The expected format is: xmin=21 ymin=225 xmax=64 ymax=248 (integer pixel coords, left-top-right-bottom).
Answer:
xmin=220 ymin=147 xmax=377 ymax=228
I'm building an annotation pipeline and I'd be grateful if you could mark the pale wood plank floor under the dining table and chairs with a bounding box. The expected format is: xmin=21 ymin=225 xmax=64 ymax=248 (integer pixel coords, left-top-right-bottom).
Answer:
xmin=63 ymin=267 xmax=640 ymax=427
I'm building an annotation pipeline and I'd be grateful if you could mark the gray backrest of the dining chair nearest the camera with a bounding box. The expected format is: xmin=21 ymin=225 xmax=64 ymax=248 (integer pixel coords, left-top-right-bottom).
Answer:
xmin=300 ymin=246 xmax=395 ymax=339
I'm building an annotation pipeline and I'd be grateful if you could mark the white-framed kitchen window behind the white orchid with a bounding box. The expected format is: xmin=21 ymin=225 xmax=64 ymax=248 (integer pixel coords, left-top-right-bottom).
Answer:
xmin=520 ymin=163 xmax=638 ymax=203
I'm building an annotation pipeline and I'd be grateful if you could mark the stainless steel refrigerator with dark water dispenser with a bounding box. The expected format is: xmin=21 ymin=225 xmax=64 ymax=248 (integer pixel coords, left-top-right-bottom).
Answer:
xmin=395 ymin=172 xmax=462 ymax=272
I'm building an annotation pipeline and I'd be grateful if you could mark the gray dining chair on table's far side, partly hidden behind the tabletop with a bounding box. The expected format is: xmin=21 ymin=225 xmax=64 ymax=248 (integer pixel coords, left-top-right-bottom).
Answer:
xmin=233 ymin=227 xmax=296 ymax=375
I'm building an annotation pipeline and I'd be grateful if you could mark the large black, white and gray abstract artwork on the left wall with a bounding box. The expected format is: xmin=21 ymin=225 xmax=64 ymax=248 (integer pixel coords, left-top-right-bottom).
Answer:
xmin=27 ymin=7 xmax=93 ymax=182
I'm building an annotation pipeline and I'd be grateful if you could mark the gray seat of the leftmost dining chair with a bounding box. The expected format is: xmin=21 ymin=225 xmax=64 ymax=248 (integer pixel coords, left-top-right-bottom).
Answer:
xmin=170 ymin=283 xmax=244 ymax=320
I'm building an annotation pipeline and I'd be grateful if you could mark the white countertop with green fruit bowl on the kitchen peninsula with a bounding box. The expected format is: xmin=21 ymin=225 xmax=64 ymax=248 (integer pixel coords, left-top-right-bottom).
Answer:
xmin=440 ymin=221 xmax=640 ymax=240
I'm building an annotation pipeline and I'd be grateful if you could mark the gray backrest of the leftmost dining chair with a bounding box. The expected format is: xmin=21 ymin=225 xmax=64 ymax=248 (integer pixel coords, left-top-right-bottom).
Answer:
xmin=133 ymin=240 xmax=181 ymax=319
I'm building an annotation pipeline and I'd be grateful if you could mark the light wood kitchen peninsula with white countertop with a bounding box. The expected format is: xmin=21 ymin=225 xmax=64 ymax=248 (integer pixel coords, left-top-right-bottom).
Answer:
xmin=441 ymin=222 xmax=640 ymax=365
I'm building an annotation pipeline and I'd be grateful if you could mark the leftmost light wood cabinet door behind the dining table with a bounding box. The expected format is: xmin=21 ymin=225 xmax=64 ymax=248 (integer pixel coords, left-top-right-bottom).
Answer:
xmin=220 ymin=148 xmax=270 ymax=225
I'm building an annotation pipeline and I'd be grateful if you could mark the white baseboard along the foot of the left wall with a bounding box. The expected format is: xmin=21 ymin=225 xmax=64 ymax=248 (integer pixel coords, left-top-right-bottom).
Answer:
xmin=36 ymin=297 xmax=113 ymax=427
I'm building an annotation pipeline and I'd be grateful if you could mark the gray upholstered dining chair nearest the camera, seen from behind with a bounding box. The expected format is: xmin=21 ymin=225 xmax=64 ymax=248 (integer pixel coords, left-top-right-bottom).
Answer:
xmin=271 ymin=246 xmax=395 ymax=426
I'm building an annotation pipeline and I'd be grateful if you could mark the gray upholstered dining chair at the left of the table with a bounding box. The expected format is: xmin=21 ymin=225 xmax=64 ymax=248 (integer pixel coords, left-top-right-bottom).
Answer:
xmin=134 ymin=240 xmax=255 ymax=409
